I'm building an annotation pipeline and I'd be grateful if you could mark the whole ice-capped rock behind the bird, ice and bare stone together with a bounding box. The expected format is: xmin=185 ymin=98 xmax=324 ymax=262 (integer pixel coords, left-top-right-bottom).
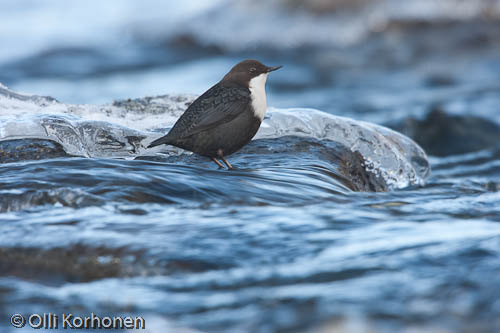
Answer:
xmin=0 ymin=85 xmax=429 ymax=191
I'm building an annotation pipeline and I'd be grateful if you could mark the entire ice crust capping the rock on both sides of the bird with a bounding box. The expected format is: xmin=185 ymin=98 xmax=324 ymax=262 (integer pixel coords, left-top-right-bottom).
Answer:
xmin=0 ymin=85 xmax=429 ymax=188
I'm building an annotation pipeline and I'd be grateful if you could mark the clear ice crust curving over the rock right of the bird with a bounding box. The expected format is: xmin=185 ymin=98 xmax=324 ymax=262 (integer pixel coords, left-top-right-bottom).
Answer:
xmin=256 ymin=109 xmax=430 ymax=188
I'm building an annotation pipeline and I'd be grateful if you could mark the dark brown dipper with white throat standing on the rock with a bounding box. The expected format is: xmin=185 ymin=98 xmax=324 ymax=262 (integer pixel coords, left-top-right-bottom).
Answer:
xmin=148 ymin=60 xmax=282 ymax=169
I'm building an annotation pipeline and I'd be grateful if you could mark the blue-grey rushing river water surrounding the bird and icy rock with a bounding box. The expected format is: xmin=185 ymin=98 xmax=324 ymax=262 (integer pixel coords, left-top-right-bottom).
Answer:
xmin=0 ymin=0 xmax=500 ymax=332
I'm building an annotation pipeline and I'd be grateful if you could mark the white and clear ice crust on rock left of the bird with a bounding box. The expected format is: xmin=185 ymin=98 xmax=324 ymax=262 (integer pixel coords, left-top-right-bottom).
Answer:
xmin=0 ymin=86 xmax=193 ymax=158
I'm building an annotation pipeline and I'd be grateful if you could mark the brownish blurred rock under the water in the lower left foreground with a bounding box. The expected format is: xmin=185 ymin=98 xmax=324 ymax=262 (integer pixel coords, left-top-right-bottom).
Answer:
xmin=0 ymin=244 xmax=236 ymax=284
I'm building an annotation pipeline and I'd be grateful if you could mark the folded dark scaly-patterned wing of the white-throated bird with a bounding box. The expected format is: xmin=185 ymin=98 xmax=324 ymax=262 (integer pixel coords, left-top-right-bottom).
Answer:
xmin=168 ymin=84 xmax=251 ymax=139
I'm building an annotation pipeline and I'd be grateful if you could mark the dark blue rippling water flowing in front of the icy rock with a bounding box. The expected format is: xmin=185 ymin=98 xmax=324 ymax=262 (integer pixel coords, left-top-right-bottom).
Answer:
xmin=0 ymin=149 xmax=500 ymax=331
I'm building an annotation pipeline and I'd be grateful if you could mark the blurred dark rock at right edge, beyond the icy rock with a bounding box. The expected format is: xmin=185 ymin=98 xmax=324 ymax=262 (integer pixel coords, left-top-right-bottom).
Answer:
xmin=387 ymin=106 xmax=500 ymax=156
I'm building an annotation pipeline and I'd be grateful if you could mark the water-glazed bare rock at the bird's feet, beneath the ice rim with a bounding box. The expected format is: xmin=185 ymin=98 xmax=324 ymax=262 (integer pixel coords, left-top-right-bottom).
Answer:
xmin=136 ymin=136 xmax=389 ymax=192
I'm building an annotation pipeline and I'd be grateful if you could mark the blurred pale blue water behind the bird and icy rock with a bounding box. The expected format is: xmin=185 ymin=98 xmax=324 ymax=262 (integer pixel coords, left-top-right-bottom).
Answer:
xmin=0 ymin=0 xmax=500 ymax=127
